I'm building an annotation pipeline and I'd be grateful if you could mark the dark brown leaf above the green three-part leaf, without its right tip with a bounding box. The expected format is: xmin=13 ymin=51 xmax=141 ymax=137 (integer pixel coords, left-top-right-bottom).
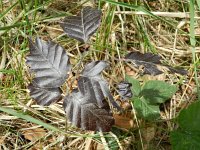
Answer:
xmin=125 ymin=52 xmax=163 ymax=75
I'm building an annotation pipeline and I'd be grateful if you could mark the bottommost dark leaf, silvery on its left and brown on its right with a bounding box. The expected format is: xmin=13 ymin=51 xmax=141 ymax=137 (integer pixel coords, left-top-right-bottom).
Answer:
xmin=63 ymin=90 xmax=114 ymax=132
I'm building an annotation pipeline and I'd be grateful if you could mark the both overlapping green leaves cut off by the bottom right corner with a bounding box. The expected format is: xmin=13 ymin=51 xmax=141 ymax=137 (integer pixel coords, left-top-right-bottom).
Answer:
xmin=170 ymin=101 xmax=200 ymax=150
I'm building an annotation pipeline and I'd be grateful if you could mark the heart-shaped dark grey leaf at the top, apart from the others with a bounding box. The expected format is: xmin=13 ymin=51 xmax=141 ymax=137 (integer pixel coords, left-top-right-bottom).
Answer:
xmin=60 ymin=6 xmax=101 ymax=43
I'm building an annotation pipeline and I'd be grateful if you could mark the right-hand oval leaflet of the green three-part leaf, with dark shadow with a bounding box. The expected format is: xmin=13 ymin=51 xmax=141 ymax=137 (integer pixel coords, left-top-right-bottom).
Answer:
xmin=140 ymin=80 xmax=177 ymax=104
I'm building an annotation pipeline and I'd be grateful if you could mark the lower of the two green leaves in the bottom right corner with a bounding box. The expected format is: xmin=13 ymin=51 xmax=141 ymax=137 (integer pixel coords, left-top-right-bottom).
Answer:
xmin=170 ymin=130 xmax=200 ymax=150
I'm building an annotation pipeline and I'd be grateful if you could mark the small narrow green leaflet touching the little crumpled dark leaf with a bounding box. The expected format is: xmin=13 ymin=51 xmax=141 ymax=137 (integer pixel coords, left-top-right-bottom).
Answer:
xmin=125 ymin=75 xmax=141 ymax=96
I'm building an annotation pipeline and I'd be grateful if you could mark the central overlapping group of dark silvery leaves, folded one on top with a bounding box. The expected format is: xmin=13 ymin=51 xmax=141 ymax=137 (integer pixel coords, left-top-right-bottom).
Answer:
xmin=64 ymin=61 xmax=121 ymax=131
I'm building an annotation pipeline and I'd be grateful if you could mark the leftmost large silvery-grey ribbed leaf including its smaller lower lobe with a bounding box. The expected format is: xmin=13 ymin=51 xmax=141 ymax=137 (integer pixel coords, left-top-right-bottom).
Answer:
xmin=26 ymin=37 xmax=71 ymax=106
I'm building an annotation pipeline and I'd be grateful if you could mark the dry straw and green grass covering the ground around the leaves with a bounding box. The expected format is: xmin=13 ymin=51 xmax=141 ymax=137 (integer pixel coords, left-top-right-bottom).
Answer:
xmin=0 ymin=0 xmax=200 ymax=149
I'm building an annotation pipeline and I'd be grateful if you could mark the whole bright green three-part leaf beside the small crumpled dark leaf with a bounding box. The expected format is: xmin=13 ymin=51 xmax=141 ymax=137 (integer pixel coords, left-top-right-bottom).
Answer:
xmin=126 ymin=76 xmax=177 ymax=121
